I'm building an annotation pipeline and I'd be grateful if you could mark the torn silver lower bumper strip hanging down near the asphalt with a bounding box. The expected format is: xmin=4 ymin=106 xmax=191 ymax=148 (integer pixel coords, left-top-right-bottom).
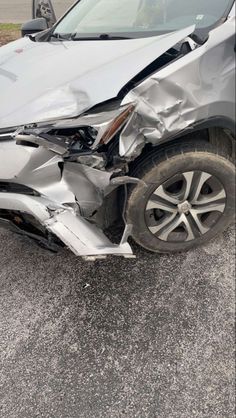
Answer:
xmin=0 ymin=193 xmax=133 ymax=259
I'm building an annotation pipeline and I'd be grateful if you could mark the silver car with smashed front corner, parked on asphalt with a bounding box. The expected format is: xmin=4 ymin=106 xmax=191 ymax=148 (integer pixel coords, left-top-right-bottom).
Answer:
xmin=0 ymin=0 xmax=235 ymax=259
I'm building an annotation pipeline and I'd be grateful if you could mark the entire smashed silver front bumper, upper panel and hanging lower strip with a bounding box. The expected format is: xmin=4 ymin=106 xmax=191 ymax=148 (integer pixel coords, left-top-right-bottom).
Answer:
xmin=0 ymin=135 xmax=134 ymax=260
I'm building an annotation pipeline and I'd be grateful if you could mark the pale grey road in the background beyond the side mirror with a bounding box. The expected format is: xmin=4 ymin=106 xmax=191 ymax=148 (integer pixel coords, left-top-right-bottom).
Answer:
xmin=0 ymin=0 xmax=74 ymax=23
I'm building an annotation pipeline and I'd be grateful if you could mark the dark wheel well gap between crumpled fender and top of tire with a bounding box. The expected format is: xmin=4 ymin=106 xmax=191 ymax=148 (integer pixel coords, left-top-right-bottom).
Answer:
xmin=130 ymin=127 xmax=236 ymax=172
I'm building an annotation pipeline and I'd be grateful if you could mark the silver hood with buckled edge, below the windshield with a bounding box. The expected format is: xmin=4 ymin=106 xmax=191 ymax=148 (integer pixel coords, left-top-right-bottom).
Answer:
xmin=0 ymin=26 xmax=194 ymax=129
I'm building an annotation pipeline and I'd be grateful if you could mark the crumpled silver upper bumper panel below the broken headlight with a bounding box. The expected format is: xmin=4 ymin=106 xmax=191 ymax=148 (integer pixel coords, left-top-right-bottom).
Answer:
xmin=0 ymin=140 xmax=113 ymax=215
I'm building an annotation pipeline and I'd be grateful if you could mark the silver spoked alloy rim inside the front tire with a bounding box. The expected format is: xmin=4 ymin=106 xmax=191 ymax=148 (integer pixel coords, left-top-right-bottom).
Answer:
xmin=145 ymin=171 xmax=226 ymax=243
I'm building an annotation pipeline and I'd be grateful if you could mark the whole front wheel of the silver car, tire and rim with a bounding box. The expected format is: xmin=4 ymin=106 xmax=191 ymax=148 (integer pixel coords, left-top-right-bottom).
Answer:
xmin=126 ymin=141 xmax=235 ymax=253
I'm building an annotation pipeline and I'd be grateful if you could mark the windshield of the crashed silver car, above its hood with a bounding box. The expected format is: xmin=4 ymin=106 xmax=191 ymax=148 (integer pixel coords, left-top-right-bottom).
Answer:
xmin=54 ymin=0 xmax=232 ymax=38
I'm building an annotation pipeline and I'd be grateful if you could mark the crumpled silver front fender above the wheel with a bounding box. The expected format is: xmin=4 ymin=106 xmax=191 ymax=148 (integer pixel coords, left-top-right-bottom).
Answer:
xmin=120 ymin=18 xmax=235 ymax=158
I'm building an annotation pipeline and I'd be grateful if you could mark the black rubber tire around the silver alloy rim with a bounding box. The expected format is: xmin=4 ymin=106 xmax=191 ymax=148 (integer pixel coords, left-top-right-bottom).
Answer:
xmin=126 ymin=141 xmax=235 ymax=253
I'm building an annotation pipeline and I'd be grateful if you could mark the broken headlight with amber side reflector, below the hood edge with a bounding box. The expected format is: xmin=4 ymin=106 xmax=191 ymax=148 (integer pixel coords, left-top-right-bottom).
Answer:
xmin=15 ymin=103 xmax=135 ymax=154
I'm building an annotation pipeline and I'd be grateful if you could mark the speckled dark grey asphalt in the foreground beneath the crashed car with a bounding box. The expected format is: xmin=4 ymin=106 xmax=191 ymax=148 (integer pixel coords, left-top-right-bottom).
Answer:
xmin=0 ymin=227 xmax=235 ymax=418
